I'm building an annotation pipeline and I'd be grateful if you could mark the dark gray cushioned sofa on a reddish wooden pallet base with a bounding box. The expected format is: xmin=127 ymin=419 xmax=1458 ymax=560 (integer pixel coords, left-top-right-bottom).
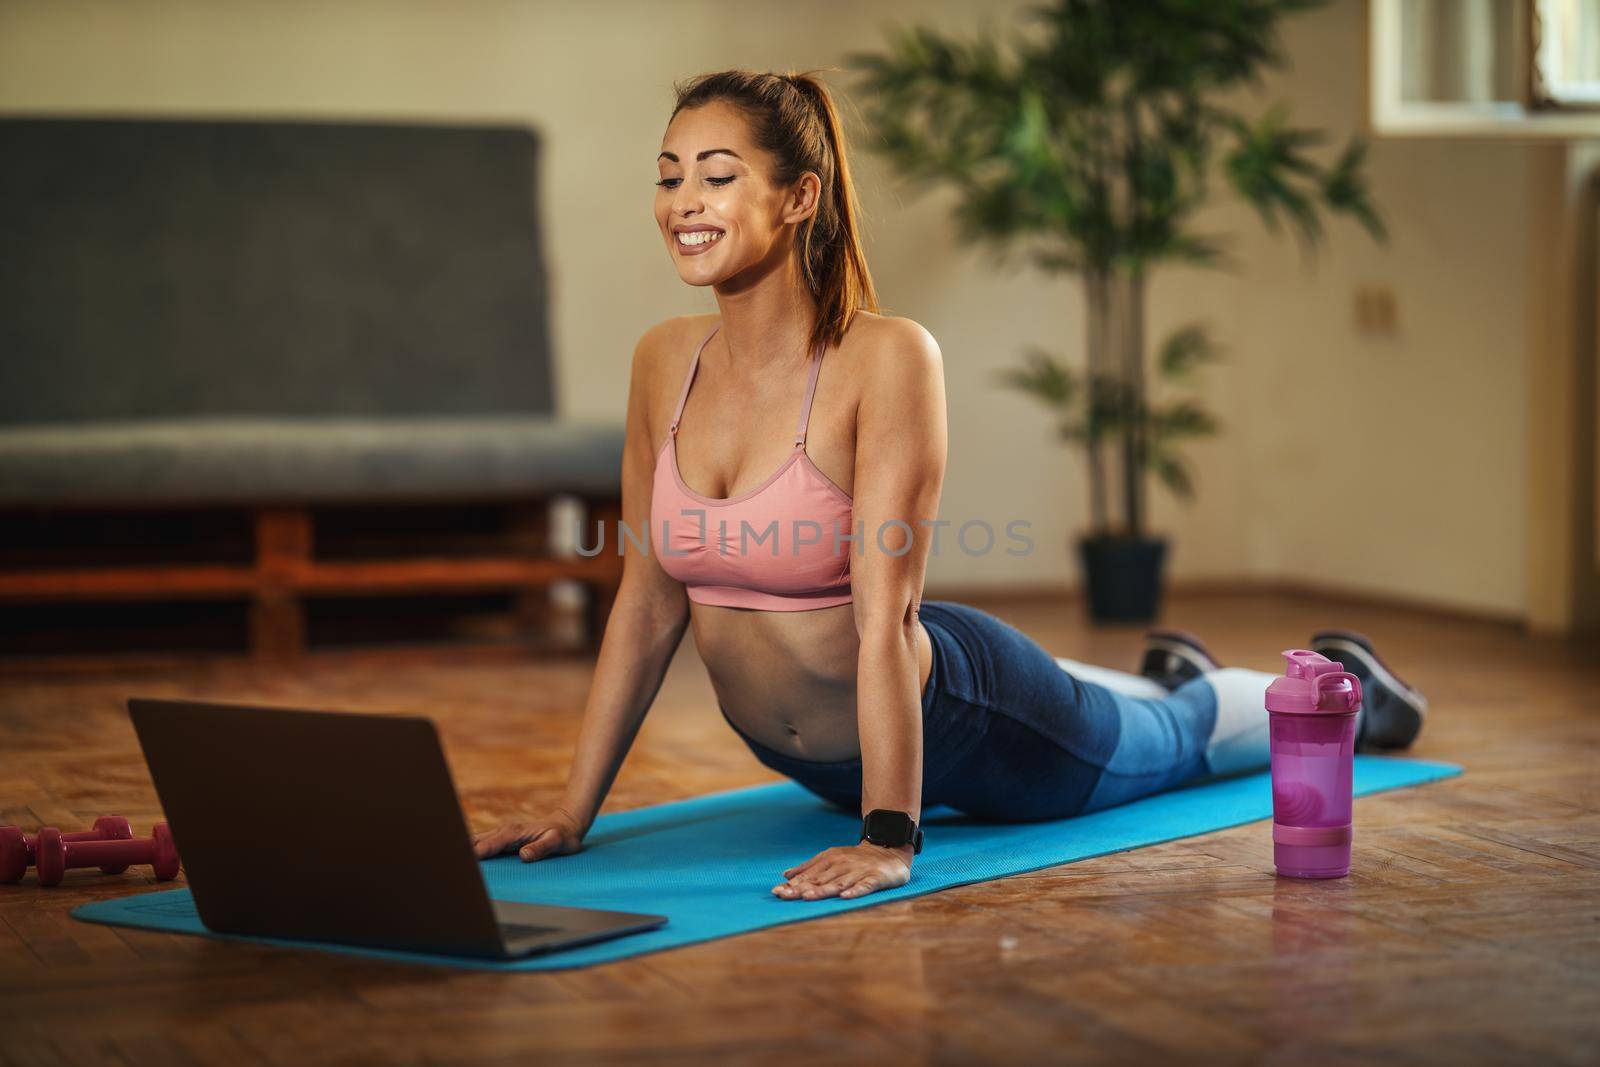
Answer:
xmin=0 ymin=117 xmax=622 ymax=657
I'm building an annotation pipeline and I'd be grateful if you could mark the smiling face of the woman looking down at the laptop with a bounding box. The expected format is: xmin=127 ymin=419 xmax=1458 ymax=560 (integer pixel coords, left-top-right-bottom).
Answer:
xmin=656 ymin=101 xmax=818 ymax=285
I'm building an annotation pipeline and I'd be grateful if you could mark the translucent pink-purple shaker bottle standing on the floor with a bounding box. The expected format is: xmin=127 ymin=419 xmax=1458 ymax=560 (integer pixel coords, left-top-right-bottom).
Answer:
xmin=1267 ymin=648 xmax=1362 ymax=878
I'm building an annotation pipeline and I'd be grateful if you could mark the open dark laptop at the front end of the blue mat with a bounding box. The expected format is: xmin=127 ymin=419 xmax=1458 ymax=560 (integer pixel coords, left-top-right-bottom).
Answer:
xmin=128 ymin=697 xmax=667 ymax=960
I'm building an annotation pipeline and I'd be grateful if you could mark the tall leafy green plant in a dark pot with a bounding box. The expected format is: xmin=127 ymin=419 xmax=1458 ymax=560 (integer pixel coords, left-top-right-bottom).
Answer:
xmin=848 ymin=0 xmax=1384 ymax=622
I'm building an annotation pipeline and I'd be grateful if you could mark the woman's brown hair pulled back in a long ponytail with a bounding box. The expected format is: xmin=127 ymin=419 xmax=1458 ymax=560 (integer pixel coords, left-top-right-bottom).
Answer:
xmin=667 ymin=70 xmax=878 ymax=355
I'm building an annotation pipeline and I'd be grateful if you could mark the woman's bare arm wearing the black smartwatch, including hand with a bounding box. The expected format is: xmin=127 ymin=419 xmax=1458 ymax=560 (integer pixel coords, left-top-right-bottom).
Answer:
xmin=774 ymin=318 xmax=947 ymax=899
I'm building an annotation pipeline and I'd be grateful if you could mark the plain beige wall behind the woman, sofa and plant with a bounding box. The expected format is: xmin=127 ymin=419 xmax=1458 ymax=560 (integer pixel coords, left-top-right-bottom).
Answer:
xmin=0 ymin=0 xmax=1528 ymax=614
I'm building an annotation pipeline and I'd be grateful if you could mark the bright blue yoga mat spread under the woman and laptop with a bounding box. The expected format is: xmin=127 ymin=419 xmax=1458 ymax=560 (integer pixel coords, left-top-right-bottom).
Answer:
xmin=72 ymin=757 xmax=1461 ymax=971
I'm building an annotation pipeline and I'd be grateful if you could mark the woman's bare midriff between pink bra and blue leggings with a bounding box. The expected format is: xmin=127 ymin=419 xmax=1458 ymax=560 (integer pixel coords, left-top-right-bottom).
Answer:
xmin=690 ymin=603 xmax=933 ymax=763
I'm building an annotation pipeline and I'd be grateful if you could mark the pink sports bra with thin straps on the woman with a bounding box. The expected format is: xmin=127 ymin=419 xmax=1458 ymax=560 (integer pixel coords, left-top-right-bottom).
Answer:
xmin=650 ymin=322 xmax=856 ymax=611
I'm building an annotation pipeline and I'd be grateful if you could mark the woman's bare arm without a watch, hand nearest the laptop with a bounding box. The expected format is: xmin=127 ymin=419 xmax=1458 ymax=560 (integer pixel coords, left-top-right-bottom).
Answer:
xmin=477 ymin=323 xmax=690 ymax=859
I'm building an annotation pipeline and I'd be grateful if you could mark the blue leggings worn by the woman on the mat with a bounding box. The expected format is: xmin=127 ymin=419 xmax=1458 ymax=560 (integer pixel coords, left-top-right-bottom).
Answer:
xmin=725 ymin=600 xmax=1270 ymax=822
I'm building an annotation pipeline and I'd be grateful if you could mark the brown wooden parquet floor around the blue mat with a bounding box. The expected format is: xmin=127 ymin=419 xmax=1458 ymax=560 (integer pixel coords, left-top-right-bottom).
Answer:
xmin=0 ymin=595 xmax=1600 ymax=1067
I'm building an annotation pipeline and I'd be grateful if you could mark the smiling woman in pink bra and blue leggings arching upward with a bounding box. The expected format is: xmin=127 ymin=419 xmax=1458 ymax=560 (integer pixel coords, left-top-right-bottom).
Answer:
xmin=475 ymin=70 xmax=1426 ymax=899
